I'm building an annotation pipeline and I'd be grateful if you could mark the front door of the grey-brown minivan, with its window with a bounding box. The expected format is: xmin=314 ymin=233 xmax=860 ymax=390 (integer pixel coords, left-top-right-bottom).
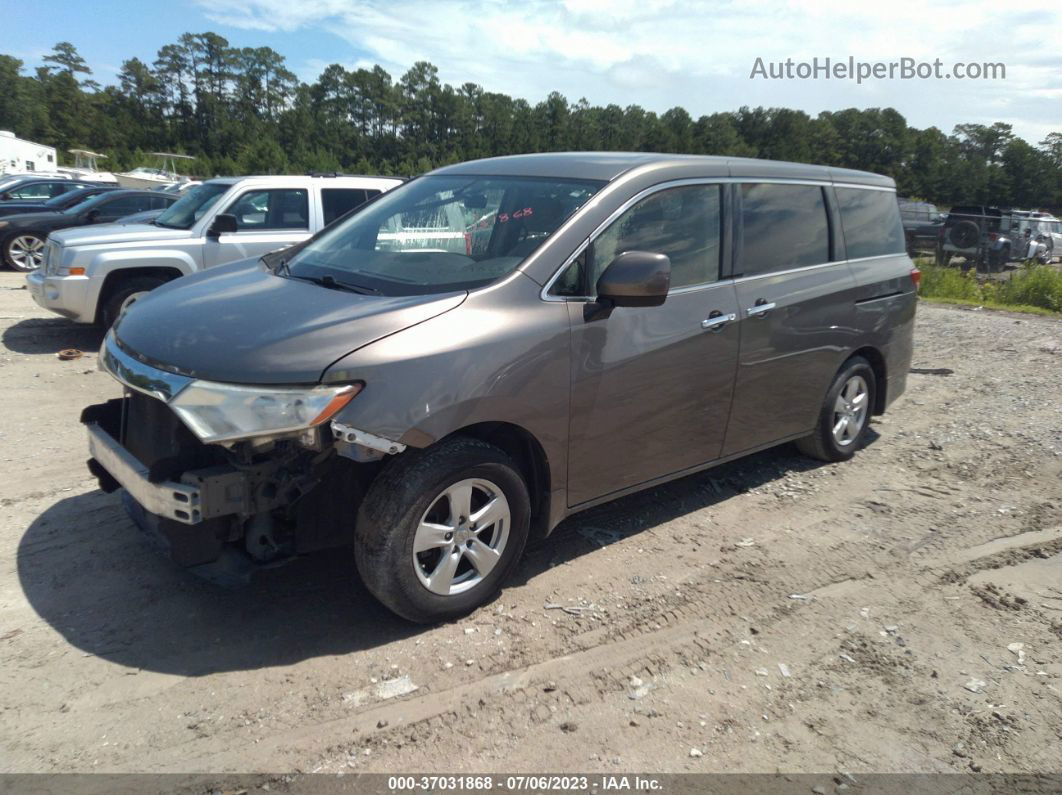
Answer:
xmin=559 ymin=185 xmax=738 ymax=505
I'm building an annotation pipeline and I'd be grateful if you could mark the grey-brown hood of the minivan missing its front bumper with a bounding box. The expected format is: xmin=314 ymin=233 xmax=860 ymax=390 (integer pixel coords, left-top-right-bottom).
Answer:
xmin=115 ymin=260 xmax=467 ymax=384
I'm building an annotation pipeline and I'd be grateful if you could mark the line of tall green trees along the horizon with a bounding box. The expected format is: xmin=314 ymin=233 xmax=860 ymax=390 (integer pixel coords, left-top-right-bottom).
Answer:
xmin=0 ymin=33 xmax=1062 ymax=208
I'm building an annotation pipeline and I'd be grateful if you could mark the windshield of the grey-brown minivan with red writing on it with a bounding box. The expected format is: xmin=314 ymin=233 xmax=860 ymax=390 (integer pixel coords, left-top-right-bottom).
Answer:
xmin=288 ymin=175 xmax=604 ymax=295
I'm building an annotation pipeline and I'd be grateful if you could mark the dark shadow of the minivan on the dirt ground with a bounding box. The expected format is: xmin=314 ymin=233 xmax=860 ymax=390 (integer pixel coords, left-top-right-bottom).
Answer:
xmin=17 ymin=434 xmax=875 ymax=676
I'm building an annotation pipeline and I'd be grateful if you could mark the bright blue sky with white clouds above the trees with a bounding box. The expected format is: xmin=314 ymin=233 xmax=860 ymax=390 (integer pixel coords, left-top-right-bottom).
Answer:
xmin=0 ymin=0 xmax=1062 ymax=144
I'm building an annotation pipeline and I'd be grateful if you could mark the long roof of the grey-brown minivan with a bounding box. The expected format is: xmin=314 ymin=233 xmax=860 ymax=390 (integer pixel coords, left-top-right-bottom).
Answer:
xmin=430 ymin=152 xmax=895 ymax=188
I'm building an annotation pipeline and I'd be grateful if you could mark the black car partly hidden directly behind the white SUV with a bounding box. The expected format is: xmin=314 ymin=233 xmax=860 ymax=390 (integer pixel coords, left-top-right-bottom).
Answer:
xmin=0 ymin=190 xmax=177 ymax=272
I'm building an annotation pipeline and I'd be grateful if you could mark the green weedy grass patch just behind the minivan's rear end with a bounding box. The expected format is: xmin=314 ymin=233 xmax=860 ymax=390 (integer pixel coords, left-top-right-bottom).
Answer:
xmin=918 ymin=260 xmax=1062 ymax=315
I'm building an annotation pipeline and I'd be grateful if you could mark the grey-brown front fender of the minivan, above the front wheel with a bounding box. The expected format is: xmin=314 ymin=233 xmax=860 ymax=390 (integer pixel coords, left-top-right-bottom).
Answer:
xmin=324 ymin=274 xmax=570 ymax=496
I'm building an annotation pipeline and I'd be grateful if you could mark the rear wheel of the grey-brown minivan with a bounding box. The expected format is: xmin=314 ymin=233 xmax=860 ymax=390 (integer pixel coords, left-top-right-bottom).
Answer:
xmin=797 ymin=357 xmax=877 ymax=461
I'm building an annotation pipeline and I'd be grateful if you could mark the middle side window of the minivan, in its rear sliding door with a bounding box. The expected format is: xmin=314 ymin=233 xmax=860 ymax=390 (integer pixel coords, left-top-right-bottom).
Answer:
xmin=739 ymin=183 xmax=828 ymax=276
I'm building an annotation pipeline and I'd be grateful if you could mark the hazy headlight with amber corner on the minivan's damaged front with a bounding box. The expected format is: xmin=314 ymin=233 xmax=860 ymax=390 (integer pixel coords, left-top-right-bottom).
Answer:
xmin=170 ymin=381 xmax=362 ymax=443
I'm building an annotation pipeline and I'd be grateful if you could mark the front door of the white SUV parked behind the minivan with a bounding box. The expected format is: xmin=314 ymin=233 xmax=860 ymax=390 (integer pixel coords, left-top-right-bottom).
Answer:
xmin=203 ymin=188 xmax=310 ymax=267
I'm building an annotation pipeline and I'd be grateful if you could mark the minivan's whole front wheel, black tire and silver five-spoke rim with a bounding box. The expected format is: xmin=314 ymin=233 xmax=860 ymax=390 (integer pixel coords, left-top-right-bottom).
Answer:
xmin=354 ymin=436 xmax=531 ymax=623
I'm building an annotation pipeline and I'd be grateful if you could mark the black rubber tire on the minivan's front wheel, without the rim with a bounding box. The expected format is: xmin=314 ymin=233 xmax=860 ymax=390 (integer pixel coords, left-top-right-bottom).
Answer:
xmin=355 ymin=439 xmax=531 ymax=623
